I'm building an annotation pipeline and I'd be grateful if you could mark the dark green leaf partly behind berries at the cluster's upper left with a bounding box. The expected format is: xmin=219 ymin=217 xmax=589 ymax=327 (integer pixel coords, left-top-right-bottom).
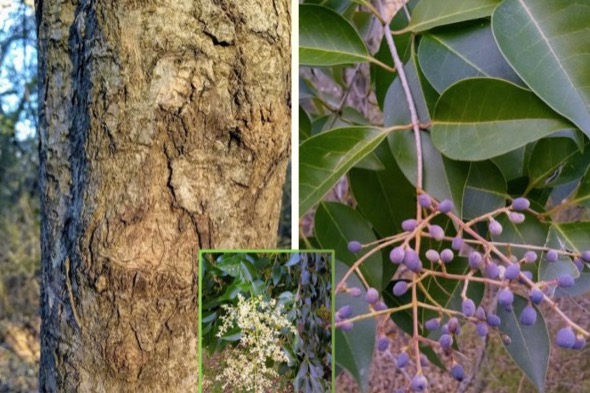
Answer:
xmin=314 ymin=202 xmax=390 ymax=290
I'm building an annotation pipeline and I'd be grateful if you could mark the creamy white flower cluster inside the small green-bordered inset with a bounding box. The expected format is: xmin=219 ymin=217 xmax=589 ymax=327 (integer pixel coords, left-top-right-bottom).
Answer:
xmin=215 ymin=294 xmax=297 ymax=393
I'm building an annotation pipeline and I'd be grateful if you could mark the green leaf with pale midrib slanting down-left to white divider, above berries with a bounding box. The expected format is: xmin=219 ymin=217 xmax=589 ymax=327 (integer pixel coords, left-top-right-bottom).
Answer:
xmin=299 ymin=127 xmax=388 ymax=216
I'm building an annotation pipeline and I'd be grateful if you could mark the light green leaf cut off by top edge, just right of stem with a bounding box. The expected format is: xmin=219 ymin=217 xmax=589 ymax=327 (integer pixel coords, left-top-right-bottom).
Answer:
xmin=408 ymin=0 xmax=501 ymax=33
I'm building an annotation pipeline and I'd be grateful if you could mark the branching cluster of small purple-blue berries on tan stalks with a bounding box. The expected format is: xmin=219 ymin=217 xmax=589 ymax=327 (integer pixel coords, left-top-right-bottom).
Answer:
xmin=335 ymin=193 xmax=590 ymax=392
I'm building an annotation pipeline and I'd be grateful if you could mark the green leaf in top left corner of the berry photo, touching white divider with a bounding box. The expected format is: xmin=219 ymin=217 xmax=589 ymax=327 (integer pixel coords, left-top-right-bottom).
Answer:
xmin=299 ymin=4 xmax=373 ymax=66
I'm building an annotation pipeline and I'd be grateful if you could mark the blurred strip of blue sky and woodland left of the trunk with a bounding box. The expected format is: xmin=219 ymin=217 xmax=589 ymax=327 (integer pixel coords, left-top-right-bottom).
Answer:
xmin=0 ymin=0 xmax=41 ymax=393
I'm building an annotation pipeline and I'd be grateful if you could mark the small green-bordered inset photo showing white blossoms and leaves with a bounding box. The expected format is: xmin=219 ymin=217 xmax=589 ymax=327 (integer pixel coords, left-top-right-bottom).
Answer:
xmin=199 ymin=250 xmax=334 ymax=393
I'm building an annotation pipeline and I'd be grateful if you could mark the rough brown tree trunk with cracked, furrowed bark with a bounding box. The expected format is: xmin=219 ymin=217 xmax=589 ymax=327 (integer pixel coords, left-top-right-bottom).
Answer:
xmin=38 ymin=0 xmax=290 ymax=392
